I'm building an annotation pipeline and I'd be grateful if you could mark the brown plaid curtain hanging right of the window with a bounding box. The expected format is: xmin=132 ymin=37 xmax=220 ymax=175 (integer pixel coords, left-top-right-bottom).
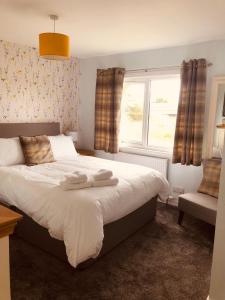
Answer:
xmin=173 ymin=59 xmax=207 ymax=166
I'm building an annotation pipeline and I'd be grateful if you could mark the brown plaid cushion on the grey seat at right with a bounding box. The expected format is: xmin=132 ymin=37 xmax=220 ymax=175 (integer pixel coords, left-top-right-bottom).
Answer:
xmin=198 ymin=159 xmax=221 ymax=198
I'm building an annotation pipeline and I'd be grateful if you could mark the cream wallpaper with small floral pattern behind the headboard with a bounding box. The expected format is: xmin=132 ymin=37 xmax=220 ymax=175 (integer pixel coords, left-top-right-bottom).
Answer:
xmin=0 ymin=40 xmax=79 ymax=131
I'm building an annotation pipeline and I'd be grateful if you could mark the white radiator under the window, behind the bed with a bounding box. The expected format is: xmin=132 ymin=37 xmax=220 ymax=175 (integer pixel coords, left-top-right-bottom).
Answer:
xmin=96 ymin=151 xmax=168 ymax=178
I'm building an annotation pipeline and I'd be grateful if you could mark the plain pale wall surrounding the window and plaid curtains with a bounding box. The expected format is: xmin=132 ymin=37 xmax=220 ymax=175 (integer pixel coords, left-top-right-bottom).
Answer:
xmin=79 ymin=41 xmax=225 ymax=191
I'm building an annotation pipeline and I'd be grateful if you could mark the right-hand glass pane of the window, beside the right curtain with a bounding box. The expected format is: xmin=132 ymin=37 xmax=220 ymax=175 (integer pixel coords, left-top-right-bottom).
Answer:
xmin=148 ymin=78 xmax=180 ymax=148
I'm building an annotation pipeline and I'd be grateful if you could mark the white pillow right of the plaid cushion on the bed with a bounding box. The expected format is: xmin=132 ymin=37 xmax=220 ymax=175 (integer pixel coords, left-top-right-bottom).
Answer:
xmin=49 ymin=134 xmax=78 ymax=160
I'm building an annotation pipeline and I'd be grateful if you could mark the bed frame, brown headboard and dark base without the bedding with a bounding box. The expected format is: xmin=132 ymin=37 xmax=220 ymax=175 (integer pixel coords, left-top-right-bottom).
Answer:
xmin=0 ymin=123 xmax=157 ymax=268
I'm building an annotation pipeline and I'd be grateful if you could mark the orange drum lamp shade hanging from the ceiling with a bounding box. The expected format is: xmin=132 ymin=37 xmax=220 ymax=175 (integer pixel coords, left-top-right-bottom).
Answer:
xmin=39 ymin=32 xmax=70 ymax=60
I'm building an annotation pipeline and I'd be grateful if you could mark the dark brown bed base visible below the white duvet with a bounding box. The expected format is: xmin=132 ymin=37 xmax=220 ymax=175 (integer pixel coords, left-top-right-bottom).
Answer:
xmin=5 ymin=197 xmax=157 ymax=269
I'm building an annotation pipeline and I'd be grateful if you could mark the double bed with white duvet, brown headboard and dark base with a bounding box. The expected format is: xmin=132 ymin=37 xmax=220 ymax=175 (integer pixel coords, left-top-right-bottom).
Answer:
xmin=0 ymin=123 xmax=169 ymax=267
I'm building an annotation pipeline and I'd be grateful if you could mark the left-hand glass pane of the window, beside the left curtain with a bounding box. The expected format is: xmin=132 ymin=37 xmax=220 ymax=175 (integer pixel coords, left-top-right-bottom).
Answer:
xmin=120 ymin=82 xmax=145 ymax=143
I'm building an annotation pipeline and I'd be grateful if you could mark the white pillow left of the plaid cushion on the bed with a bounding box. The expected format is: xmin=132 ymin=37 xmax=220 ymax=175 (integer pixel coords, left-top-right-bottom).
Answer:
xmin=0 ymin=137 xmax=25 ymax=166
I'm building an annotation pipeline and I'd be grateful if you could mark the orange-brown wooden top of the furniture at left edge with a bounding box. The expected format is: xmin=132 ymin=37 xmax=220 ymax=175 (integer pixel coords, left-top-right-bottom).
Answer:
xmin=0 ymin=205 xmax=22 ymax=238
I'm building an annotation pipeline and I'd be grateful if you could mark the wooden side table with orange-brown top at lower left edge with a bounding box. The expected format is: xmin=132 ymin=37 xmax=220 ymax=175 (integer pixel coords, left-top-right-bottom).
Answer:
xmin=0 ymin=205 xmax=22 ymax=300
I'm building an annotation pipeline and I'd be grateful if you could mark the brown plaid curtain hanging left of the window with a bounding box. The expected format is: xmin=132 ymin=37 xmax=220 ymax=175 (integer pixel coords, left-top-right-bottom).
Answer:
xmin=95 ymin=68 xmax=125 ymax=153
